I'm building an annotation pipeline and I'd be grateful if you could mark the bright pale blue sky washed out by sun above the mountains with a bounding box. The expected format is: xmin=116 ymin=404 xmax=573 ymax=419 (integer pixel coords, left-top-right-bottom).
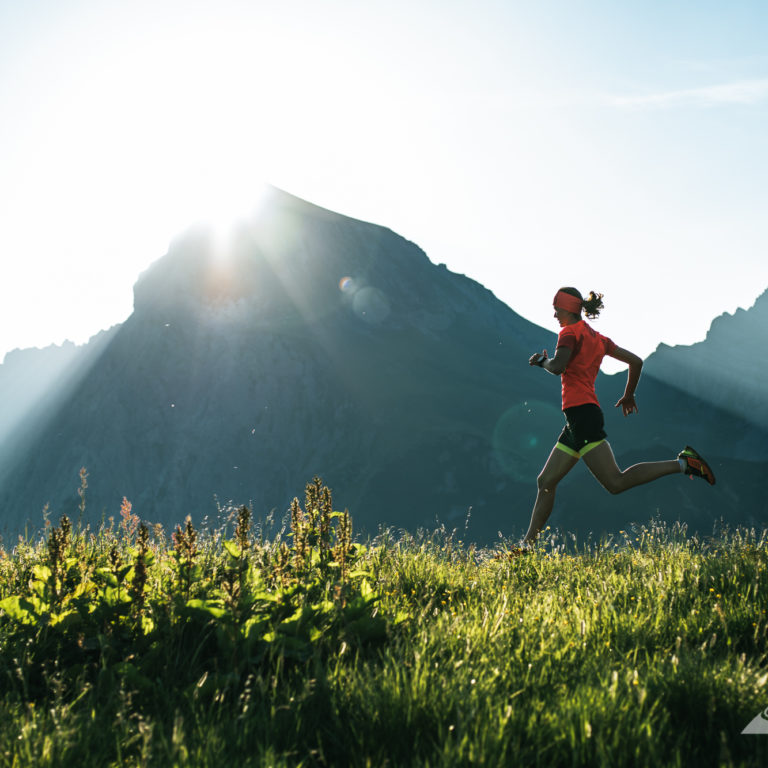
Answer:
xmin=0 ymin=0 xmax=768 ymax=372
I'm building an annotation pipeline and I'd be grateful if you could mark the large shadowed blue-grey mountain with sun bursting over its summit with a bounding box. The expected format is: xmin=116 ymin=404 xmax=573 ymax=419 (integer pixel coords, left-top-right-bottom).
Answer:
xmin=0 ymin=190 xmax=768 ymax=543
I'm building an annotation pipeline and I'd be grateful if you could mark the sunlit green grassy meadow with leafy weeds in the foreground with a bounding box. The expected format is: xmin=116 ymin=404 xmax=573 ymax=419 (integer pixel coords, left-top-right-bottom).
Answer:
xmin=0 ymin=476 xmax=768 ymax=768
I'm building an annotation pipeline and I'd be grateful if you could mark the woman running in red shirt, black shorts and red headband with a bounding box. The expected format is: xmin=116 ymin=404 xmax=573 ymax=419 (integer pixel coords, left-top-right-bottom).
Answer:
xmin=522 ymin=288 xmax=715 ymax=546
